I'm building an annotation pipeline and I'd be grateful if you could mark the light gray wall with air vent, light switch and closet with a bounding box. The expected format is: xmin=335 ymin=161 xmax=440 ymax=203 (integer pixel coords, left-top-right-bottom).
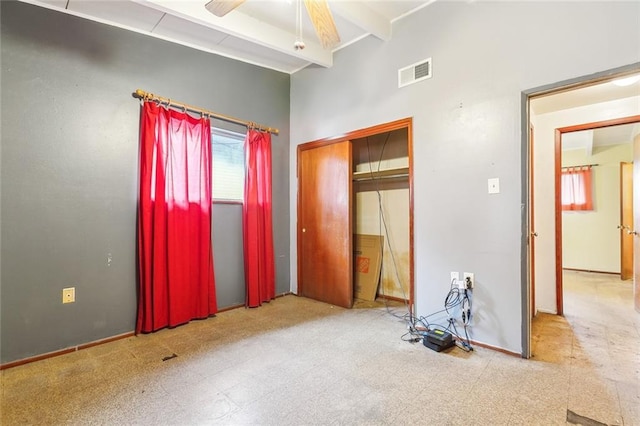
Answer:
xmin=290 ymin=2 xmax=640 ymax=353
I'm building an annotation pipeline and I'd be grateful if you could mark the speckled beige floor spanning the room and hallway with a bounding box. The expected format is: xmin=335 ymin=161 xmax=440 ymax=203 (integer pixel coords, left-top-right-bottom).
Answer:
xmin=0 ymin=273 xmax=640 ymax=425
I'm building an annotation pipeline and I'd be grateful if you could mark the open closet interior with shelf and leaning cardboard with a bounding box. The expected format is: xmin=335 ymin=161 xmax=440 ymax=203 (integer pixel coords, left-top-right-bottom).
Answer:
xmin=352 ymin=128 xmax=410 ymax=303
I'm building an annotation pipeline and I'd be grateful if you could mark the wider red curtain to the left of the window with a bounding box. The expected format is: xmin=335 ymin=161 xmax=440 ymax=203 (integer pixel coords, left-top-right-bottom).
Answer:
xmin=136 ymin=102 xmax=217 ymax=333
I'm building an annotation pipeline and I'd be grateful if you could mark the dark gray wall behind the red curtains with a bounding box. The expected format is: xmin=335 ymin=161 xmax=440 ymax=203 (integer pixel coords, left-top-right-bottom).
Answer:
xmin=0 ymin=1 xmax=290 ymax=363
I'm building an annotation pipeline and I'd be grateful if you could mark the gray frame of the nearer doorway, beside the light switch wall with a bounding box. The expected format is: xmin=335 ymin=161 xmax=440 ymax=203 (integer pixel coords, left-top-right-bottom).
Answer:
xmin=520 ymin=62 xmax=640 ymax=358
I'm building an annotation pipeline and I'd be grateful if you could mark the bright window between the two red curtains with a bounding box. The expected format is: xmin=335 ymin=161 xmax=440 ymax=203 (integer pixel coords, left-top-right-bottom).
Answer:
xmin=211 ymin=128 xmax=245 ymax=202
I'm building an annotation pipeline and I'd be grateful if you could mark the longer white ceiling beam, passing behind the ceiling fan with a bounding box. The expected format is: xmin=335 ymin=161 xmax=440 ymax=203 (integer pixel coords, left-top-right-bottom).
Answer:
xmin=133 ymin=0 xmax=333 ymax=68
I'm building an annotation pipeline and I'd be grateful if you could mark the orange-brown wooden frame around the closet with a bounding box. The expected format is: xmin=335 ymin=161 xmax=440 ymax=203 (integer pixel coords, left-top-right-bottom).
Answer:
xmin=296 ymin=117 xmax=415 ymax=314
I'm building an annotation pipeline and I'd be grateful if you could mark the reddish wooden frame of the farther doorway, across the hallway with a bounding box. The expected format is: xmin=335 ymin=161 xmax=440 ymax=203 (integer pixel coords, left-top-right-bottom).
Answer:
xmin=555 ymin=115 xmax=640 ymax=315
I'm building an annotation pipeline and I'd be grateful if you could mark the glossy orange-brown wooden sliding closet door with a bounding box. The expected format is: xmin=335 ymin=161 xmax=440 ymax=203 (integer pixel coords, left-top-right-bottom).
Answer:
xmin=298 ymin=141 xmax=353 ymax=308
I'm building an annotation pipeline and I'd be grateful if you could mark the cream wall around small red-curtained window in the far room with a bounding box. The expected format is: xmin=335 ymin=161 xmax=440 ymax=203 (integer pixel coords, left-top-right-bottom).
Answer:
xmin=562 ymin=145 xmax=633 ymax=274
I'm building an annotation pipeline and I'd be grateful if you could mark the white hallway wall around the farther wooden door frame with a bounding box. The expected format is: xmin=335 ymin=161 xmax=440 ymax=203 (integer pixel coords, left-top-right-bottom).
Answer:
xmin=531 ymin=98 xmax=640 ymax=313
